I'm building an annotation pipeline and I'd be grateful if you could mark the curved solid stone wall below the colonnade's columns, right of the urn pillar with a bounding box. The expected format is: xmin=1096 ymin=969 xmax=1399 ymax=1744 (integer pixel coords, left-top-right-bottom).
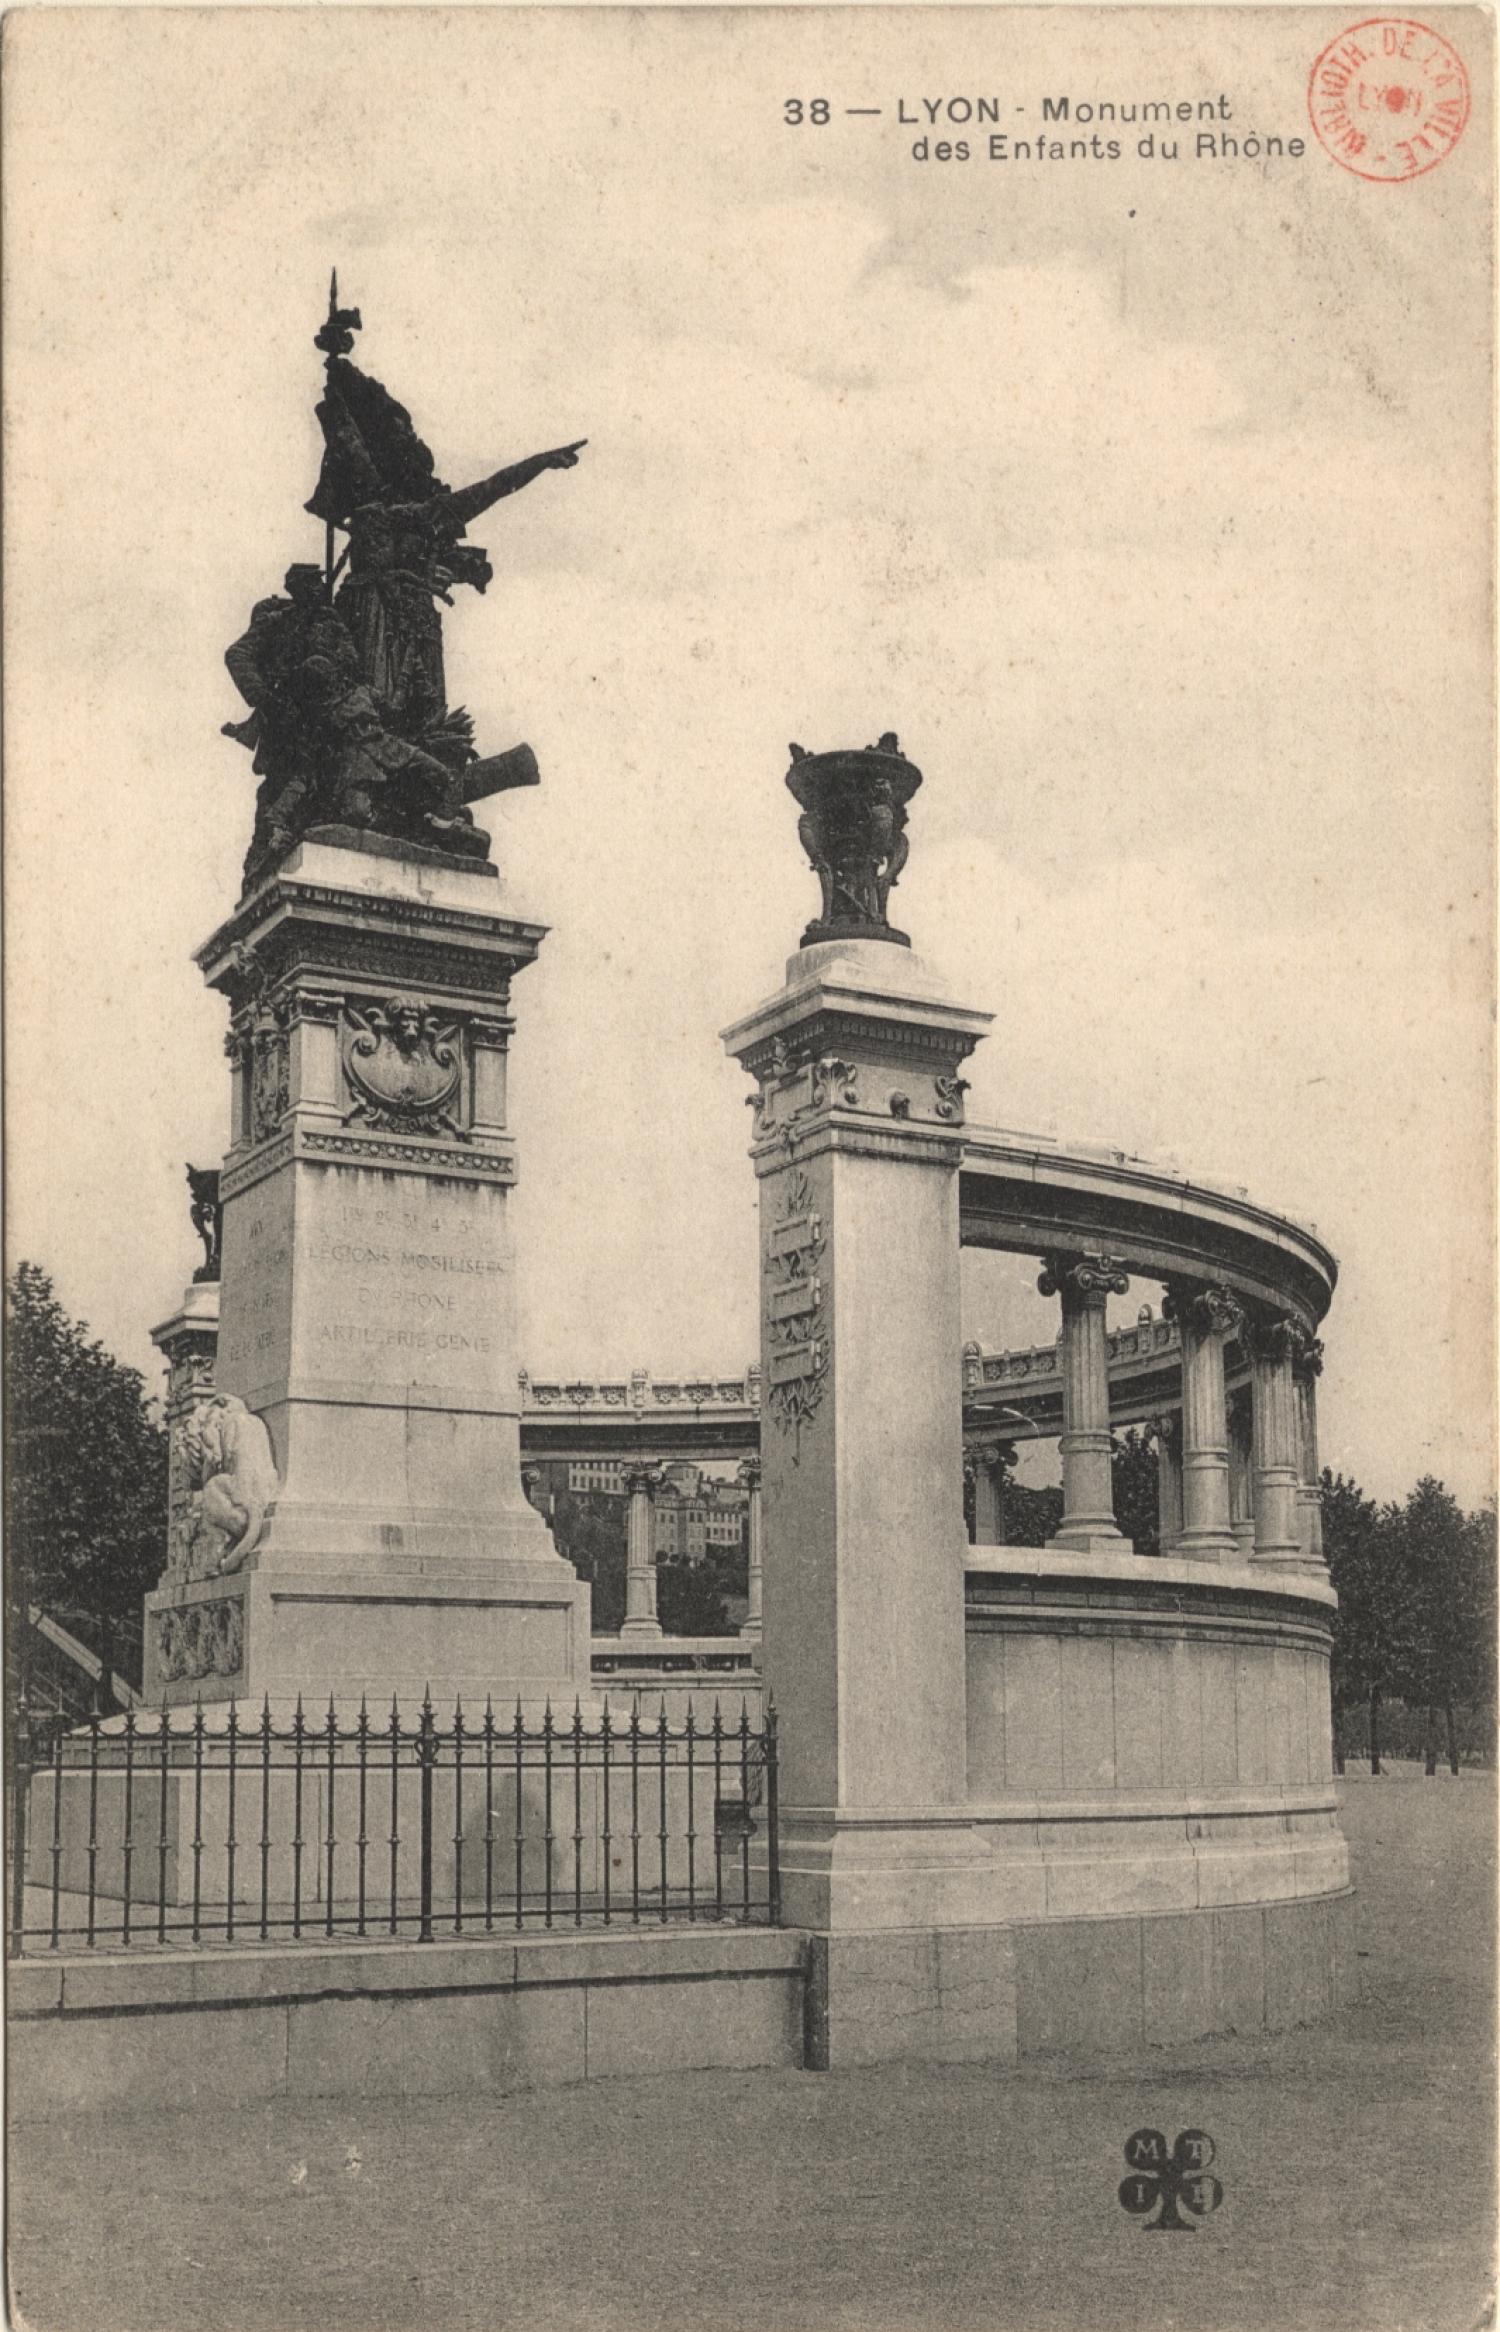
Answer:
xmin=966 ymin=1548 xmax=1358 ymax=2052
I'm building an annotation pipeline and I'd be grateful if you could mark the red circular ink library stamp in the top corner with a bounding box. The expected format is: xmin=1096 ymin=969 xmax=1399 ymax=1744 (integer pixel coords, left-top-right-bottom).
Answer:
xmin=1306 ymin=16 xmax=1470 ymax=184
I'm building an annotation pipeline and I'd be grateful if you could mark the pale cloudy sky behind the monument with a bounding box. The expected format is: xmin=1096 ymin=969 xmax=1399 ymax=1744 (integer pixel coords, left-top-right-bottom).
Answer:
xmin=5 ymin=7 xmax=1493 ymax=1499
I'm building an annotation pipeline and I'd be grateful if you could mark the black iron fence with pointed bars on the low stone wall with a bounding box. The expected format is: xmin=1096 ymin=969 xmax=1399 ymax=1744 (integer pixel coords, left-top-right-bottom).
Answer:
xmin=9 ymin=1700 xmax=781 ymax=1954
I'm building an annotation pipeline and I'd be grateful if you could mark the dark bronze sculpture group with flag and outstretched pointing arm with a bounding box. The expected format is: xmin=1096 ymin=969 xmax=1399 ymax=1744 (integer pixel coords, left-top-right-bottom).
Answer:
xmin=224 ymin=280 xmax=586 ymax=886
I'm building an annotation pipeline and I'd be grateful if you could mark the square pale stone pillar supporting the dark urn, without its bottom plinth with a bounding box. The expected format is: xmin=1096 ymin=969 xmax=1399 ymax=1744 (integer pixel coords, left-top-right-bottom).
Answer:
xmin=726 ymin=940 xmax=989 ymax=1933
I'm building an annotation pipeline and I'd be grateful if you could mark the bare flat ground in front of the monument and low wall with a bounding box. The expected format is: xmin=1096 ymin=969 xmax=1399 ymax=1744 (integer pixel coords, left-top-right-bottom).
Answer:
xmin=9 ymin=1770 xmax=1495 ymax=2332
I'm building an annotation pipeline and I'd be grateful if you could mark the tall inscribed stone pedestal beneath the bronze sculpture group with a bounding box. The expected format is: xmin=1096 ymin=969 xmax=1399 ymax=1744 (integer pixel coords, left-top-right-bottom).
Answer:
xmin=145 ymin=842 xmax=590 ymax=1705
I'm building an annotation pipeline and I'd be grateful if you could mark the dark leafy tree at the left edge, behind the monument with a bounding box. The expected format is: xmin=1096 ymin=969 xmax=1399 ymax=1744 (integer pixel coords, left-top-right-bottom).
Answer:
xmin=5 ymin=1264 xmax=166 ymax=1665
